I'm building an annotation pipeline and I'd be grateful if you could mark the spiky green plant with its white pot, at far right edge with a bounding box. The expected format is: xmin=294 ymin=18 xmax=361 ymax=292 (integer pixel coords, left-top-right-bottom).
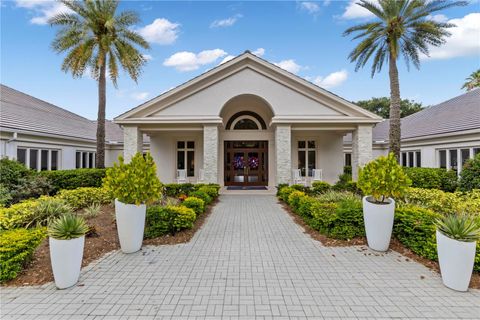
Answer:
xmin=436 ymin=215 xmax=480 ymax=291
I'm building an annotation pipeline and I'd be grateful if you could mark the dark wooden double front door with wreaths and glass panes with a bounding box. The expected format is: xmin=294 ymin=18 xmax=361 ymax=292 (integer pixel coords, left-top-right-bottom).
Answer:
xmin=225 ymin=141 xmax=268 ymax=186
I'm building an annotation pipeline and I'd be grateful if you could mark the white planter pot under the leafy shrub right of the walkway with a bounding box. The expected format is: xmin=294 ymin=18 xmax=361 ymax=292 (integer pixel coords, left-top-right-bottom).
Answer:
xmin=363 ymin=196 xmax=395 ymax=251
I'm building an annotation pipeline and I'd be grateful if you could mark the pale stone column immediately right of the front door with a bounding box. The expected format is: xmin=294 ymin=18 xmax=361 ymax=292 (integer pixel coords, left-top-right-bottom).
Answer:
xmin=275 ymin=124 xmax=292 ymax=185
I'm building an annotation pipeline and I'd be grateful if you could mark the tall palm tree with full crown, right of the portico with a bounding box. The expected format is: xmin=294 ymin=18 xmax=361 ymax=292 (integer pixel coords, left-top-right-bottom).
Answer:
xmin=343 ymin=0 xmax=466 ymax=160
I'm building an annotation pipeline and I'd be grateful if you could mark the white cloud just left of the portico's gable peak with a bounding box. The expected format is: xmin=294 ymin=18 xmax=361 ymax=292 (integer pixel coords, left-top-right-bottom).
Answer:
xmin=163 ymin=49 xmax=227 ymax=72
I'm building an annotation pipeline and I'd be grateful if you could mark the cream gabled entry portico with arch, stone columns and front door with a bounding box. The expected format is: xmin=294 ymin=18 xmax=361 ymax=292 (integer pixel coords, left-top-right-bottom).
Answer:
xmin=115 ymin=52 xmax=381 ymax=187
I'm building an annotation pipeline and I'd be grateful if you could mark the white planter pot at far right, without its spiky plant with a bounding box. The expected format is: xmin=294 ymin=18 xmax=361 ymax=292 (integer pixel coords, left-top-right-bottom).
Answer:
xmin=437 ymin=230 xmax=477 ymax=291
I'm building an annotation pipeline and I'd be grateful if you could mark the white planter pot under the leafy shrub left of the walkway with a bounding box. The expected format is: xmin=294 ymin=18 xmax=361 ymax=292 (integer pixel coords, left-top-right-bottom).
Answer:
xmin=115 ymin=199 xmax=147 ymax=253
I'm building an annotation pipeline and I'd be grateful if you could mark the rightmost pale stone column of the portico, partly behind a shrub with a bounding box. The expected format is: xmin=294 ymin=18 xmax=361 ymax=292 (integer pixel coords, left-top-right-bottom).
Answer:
xmin=352 ymin=124 xmax=374 ymax=180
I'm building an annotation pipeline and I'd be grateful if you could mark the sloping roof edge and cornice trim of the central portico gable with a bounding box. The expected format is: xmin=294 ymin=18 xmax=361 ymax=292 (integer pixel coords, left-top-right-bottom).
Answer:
xmin=114 ymin=51 xmax=381 ymax=123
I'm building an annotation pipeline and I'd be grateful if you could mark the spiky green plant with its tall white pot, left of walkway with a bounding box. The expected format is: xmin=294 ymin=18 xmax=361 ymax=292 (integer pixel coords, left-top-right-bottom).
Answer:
xmin=48 ymin=213 xmax=89 ymax=289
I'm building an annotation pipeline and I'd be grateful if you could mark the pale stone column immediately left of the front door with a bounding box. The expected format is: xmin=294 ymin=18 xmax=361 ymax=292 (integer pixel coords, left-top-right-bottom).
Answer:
xmin=203 ymin=124 xmax=218 ymax=183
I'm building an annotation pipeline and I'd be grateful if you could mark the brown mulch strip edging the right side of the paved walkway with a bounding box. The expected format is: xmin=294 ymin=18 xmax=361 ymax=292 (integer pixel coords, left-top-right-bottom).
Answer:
xmin=279 ymin=201 xmax=480 ymax=289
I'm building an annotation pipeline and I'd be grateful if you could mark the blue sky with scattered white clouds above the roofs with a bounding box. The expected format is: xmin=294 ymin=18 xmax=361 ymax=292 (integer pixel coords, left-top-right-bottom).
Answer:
xmin=0 ymin=0 xmax=480 ymax=119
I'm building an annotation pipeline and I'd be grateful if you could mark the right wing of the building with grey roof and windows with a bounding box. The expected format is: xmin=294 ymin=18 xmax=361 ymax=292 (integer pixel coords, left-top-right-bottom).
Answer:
xmin=344 ymin=89 xmax=480 ymax=174
